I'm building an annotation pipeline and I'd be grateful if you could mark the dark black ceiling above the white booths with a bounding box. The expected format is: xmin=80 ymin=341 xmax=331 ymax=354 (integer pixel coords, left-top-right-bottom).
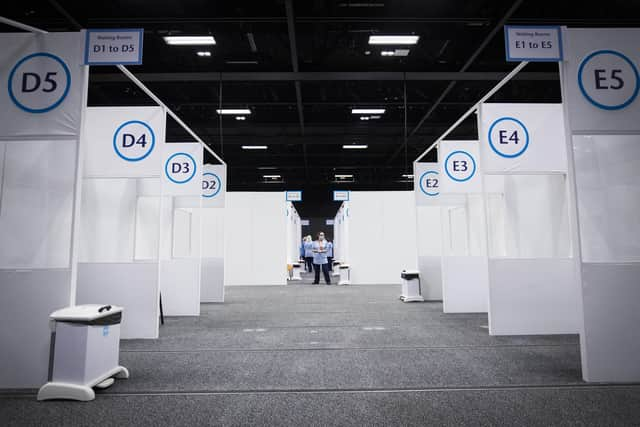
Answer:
xmin=0 ymin=0 xmax=640 ymax=216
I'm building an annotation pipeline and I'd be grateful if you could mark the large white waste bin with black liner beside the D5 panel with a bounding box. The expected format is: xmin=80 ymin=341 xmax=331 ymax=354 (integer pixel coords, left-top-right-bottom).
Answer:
xmin=38 ymin=304 xmax=129 ymax=401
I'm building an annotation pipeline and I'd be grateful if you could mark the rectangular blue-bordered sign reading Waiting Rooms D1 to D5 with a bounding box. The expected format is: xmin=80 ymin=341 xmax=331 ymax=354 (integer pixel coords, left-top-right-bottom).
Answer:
xmin=84 ymin=28 xmax=144 ymax=65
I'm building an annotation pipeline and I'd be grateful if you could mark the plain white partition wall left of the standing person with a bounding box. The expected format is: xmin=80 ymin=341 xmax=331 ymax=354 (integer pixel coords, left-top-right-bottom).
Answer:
xmin=224 ymin=192 xmax=287 ymax=286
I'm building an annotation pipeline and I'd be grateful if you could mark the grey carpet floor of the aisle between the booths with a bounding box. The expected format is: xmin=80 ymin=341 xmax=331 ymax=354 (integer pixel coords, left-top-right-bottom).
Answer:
xmin=0 ymin=275 xmax=640 ymax=426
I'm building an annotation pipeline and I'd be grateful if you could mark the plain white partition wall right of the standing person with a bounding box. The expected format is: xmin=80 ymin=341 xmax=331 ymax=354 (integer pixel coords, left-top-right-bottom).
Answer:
xmin=344 ymin=191 xmax=417 ymax=285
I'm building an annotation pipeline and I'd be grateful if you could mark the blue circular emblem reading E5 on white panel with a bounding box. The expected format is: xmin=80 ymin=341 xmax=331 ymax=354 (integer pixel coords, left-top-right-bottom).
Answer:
xmin=578 ymin=50 xmax=640 ymax=110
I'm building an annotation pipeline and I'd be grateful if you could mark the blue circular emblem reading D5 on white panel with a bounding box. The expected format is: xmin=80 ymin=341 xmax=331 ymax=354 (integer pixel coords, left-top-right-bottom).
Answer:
xmin=8 ymin=52 xmax=71 ymax=114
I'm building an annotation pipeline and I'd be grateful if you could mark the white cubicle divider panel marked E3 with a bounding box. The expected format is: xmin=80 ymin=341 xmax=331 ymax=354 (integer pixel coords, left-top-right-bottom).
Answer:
xmin=438 ymin=141 xmax=489 ymax=313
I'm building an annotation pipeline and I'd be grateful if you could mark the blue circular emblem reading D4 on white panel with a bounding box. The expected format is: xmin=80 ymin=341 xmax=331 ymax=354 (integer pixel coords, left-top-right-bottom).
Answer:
xmin=113 ymin=120 xmax=156 ymax=162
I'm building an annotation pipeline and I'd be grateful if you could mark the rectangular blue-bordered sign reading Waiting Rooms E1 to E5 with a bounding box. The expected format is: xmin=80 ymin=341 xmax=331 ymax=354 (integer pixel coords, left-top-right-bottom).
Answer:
xmin=504 ymin=25 xmax=562 ymax=62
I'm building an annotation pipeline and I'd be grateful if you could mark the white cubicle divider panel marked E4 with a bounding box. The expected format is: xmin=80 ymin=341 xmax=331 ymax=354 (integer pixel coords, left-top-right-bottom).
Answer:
xmin=478 ymin=104 xmax=580 ymax=335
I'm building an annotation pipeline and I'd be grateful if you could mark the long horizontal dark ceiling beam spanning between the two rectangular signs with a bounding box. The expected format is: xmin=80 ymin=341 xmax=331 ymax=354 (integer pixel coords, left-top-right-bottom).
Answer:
xmin=90 ymin=71 xmax=559 ymax=83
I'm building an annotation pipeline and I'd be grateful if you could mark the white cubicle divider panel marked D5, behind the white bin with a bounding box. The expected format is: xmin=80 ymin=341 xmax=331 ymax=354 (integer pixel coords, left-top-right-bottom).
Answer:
xmin=0 ymin=32 xmax=88 ymax=388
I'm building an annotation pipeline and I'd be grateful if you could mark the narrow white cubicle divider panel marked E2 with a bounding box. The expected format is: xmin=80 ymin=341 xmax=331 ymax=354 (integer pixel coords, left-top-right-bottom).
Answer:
xmin=413 ymin=162 xmax=443 ymax=301
